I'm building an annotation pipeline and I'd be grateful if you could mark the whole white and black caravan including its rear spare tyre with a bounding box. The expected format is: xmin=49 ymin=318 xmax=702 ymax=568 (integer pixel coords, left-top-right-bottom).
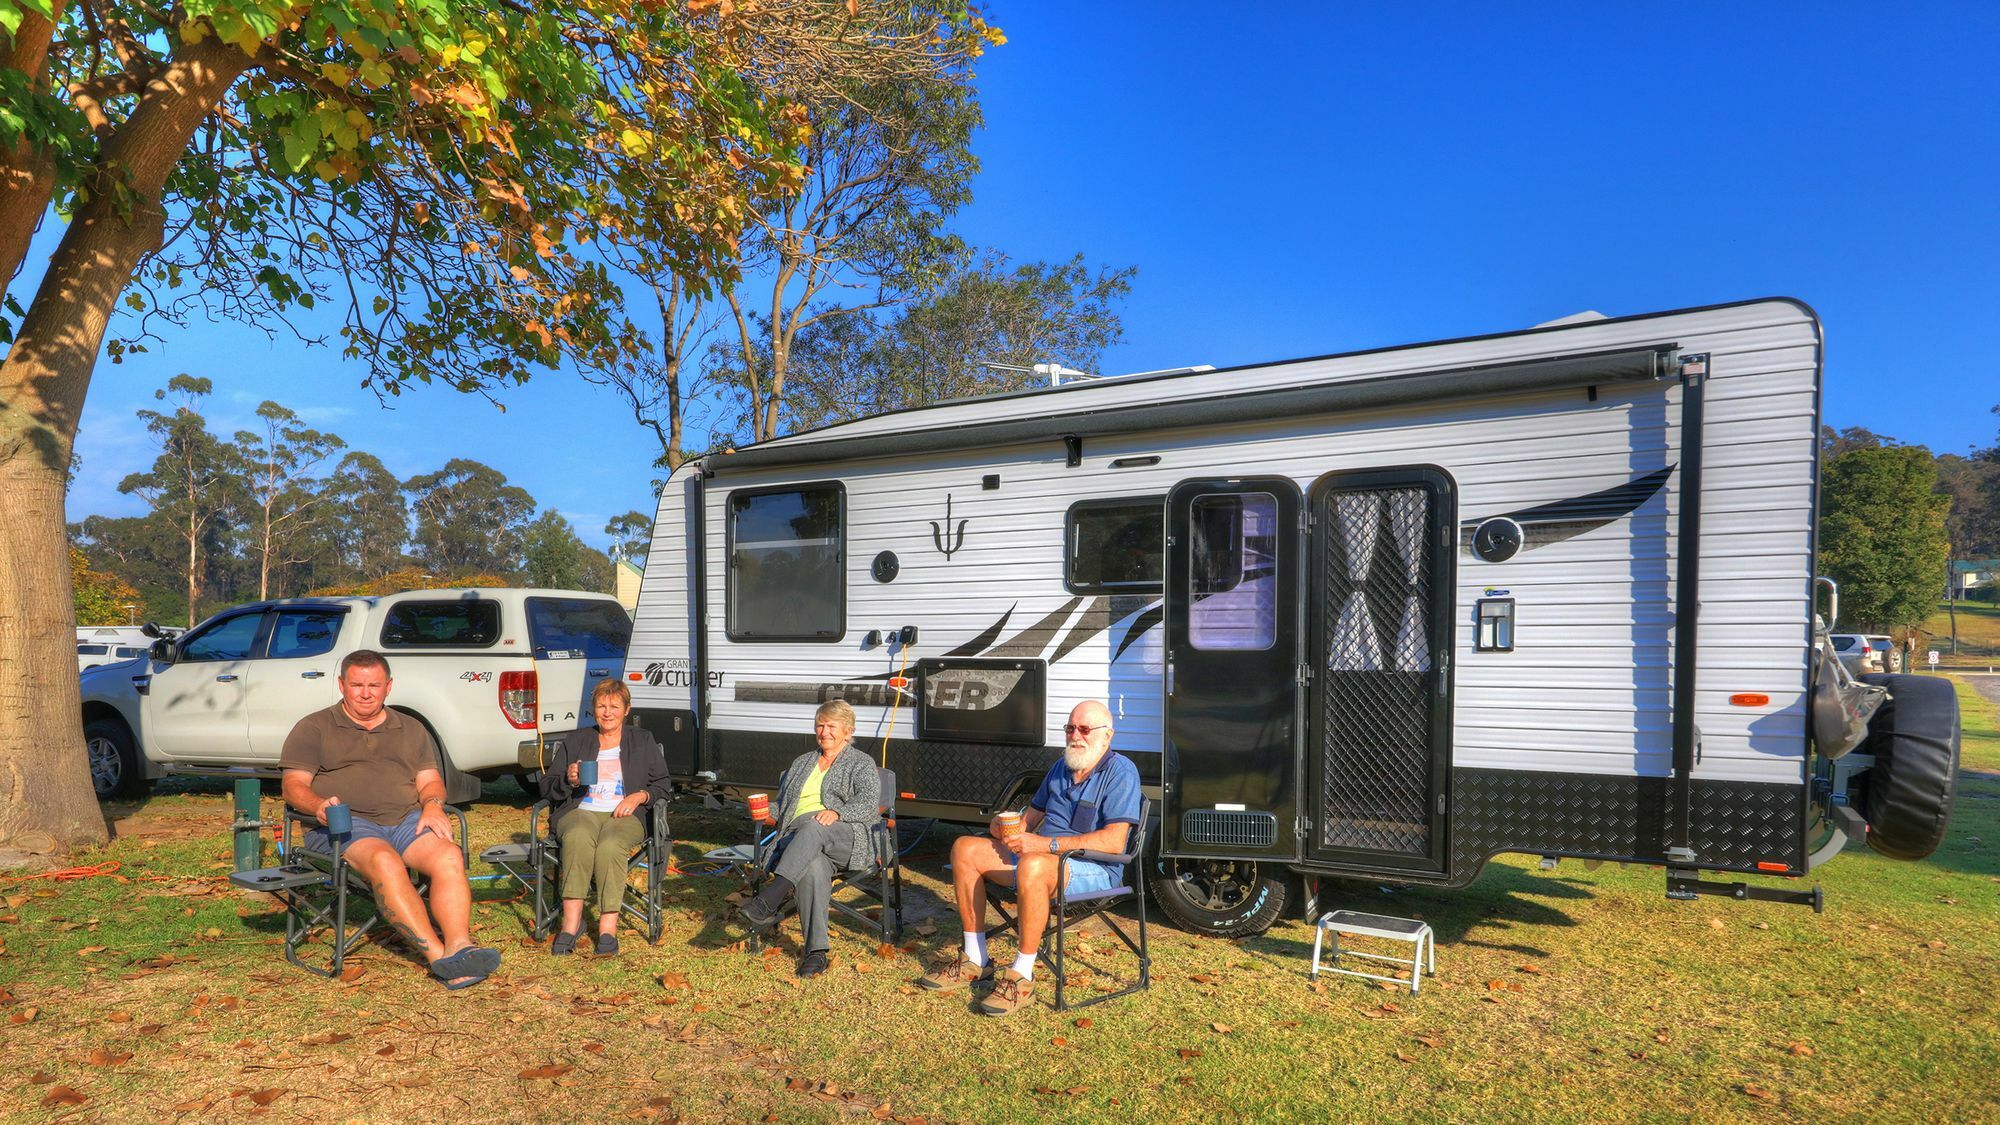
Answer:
xmin=626 ymin=298 xmax=1958 ymax=935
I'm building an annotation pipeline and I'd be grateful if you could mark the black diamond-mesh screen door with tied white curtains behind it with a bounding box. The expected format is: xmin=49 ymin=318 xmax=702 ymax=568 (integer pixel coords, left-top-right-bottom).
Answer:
xmin=1302 ymin=468 xmax=1456 ymax=873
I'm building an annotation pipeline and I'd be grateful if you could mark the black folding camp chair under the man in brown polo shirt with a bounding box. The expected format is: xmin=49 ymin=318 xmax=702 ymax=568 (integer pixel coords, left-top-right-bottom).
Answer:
xmin=230 ymin=805 xmax=470 ymax=977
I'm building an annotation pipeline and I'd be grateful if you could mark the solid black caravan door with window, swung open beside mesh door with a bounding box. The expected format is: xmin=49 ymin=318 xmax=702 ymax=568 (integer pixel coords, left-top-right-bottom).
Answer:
xmin=1160 ymin=476 xmax=1302 ymax=859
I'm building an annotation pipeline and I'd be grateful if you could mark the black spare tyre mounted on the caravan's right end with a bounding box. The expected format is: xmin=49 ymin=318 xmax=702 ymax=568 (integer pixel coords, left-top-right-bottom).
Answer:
xmin=1860 ymin=673 xmax=1958 ymax=859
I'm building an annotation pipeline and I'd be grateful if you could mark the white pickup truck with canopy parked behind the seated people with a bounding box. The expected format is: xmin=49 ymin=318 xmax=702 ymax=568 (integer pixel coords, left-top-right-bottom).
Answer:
xmin=82 ymin=589 xmax=632 ymax=803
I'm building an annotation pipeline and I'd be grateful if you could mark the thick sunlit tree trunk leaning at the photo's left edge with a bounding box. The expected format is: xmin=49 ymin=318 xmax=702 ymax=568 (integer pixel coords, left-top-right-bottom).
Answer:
xmin=0 ymin=40 xmax=250 ymax=851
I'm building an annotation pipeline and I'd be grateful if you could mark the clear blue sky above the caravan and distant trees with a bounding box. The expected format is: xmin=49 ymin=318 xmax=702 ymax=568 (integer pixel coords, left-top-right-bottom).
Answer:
xmin=54 ymin=2 xmax=2000 ymax=542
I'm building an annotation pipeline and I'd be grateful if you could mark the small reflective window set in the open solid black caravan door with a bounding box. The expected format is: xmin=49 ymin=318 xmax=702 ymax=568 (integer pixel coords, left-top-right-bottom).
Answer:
xmin=1188 ymin=492 xmax=1278 ymax=651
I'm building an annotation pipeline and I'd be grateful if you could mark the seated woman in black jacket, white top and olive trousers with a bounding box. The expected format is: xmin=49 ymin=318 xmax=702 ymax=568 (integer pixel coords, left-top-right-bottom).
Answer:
xmin=542 ymin=681 xmax=674 ymax=955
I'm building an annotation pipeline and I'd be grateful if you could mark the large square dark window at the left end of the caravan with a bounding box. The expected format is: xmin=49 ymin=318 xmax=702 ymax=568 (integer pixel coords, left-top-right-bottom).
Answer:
xmin=728 ymin=484 xmax=846 ymax=641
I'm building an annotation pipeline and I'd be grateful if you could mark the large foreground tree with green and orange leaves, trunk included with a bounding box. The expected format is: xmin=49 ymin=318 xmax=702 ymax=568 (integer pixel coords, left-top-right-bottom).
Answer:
xmin=0 ymin=0 xmax=802 ymax=849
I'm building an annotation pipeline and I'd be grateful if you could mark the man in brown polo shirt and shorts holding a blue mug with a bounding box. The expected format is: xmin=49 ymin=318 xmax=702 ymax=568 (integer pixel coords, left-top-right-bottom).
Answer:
xmin=278 ymin=649 xmax=500 ymax=989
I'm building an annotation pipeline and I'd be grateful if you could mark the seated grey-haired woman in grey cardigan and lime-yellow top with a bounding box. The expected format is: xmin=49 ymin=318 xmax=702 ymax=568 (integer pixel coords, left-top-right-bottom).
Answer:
xmin=742 ymin=699 xmax=882 ymax=977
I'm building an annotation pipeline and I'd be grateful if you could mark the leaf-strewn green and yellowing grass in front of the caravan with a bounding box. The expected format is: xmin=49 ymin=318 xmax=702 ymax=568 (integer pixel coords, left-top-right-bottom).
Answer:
xmin=0 ymin=700 xmax=2000 ymax=1121
